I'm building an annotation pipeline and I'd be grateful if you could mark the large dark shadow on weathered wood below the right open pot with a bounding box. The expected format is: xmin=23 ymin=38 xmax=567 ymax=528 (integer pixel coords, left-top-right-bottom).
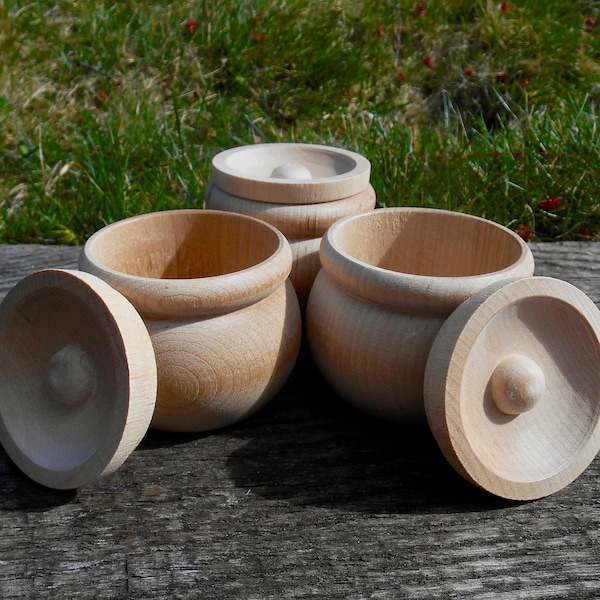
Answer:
xmin=223 ymin=356 xmax=514 ymax=514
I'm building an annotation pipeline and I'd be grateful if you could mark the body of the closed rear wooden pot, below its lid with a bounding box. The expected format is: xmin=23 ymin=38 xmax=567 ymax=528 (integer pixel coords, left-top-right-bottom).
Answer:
xmin=205 ymin=181 xmax=376 ymax=309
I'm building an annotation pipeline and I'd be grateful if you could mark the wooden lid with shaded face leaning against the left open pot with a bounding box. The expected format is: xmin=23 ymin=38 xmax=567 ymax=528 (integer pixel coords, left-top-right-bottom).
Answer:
xmin=0 ymin=269 xmax=157 ymax=489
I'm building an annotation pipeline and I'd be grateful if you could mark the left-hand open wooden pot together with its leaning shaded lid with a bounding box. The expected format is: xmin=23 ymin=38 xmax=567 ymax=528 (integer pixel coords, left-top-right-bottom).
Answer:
xmin=0 ymin=210 xmax=302 ymax=489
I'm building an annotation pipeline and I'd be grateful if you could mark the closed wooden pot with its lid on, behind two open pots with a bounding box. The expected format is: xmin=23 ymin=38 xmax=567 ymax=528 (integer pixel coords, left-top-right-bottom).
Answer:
xmin=205 ymin=143 xmax=376 ymax=309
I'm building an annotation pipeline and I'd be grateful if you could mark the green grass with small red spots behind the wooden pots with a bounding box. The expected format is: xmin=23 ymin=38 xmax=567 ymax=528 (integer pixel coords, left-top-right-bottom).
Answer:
xmin=0 ymin=0 xmax=600 ymax=244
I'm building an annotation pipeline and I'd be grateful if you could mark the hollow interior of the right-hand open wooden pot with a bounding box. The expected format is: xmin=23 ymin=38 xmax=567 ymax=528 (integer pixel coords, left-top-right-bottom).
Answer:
xmin=335 ymin=209 xmax=523 ymax=277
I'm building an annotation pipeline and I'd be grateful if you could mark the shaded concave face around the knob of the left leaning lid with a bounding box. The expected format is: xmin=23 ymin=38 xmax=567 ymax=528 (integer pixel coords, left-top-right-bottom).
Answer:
xmin=0 ymin=287 xmax=120 ymax=471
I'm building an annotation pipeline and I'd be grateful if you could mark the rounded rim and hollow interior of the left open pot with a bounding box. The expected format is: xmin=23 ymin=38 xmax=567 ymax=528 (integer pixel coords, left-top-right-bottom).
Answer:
xmin=80 ymin=209 xmax=292 ymax=318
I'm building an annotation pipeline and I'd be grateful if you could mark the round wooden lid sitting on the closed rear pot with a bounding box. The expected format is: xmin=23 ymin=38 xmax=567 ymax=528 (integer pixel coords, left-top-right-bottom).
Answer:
xmin=212 ymin=143 xmax=371 ymax=204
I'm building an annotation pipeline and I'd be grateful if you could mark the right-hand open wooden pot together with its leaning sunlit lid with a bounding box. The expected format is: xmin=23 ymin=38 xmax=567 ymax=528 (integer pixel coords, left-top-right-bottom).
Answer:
xmin=306 ymin=208 xmax=600 ymax=500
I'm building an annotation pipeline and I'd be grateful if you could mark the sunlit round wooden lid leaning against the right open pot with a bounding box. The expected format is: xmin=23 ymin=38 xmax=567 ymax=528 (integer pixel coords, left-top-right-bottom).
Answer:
xmin=424 ymin=277 xmax=600 ymax=500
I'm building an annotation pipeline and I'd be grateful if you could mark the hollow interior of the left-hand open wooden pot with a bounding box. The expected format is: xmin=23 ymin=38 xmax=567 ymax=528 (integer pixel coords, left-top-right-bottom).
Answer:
xmin=94 ymin=210 xmax=282 ymax=279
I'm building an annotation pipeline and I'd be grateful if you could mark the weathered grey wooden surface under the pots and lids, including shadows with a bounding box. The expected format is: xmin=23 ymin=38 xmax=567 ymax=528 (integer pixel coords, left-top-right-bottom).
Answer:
xmin=0 ymin=242 xmax=600 ymax=600
